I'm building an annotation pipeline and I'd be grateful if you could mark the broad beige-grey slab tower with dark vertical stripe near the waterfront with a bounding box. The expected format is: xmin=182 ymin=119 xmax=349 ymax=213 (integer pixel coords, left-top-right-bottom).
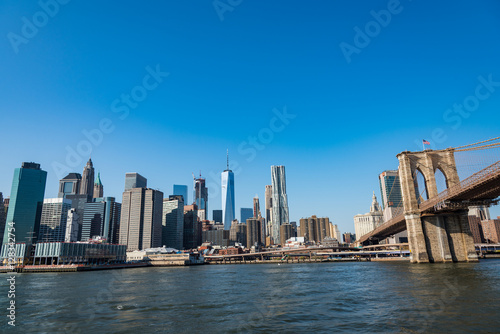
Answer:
xmin=119 ymin=188 xmax=163 ymax=251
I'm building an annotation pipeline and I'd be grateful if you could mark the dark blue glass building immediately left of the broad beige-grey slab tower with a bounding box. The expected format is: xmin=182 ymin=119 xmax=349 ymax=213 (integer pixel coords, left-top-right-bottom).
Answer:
xmin=81 ymin=197 xmax=121 ymax=244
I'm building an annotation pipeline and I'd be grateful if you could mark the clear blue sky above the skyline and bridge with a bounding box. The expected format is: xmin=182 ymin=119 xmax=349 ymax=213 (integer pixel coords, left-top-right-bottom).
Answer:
xmin=0 ymin=0 xmax=500 ymax=232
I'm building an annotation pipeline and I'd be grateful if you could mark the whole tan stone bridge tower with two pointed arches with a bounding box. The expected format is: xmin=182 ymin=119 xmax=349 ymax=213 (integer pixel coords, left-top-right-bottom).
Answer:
xmin=397 ymin=148 xmax=477 ymax=263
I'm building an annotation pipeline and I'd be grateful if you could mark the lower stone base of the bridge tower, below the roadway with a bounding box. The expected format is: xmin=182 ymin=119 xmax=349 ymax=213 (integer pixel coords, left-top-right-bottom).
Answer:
xmin=405 ymin=210 xmax=477 ymax=263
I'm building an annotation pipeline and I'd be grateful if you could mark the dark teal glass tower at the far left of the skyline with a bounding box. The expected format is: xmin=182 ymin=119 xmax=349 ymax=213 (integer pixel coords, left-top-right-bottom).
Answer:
xmin=3 ymin=162 xmax=47 ymax=245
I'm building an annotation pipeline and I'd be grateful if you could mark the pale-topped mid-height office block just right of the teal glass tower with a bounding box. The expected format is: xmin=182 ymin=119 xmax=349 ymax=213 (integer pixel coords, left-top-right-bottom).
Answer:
xmin=38 ymin=198 xmax=71 ymax=242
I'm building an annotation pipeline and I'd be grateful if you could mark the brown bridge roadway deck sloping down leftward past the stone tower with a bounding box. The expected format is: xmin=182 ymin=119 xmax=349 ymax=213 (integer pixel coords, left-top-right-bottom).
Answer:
xmin=358 ymin=161 xmax=500 ymax=244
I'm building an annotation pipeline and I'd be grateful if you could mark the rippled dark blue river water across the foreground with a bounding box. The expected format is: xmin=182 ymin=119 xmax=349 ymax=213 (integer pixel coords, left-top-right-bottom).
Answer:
xmin=0 ymin=260 xmax=500 ymax=333
